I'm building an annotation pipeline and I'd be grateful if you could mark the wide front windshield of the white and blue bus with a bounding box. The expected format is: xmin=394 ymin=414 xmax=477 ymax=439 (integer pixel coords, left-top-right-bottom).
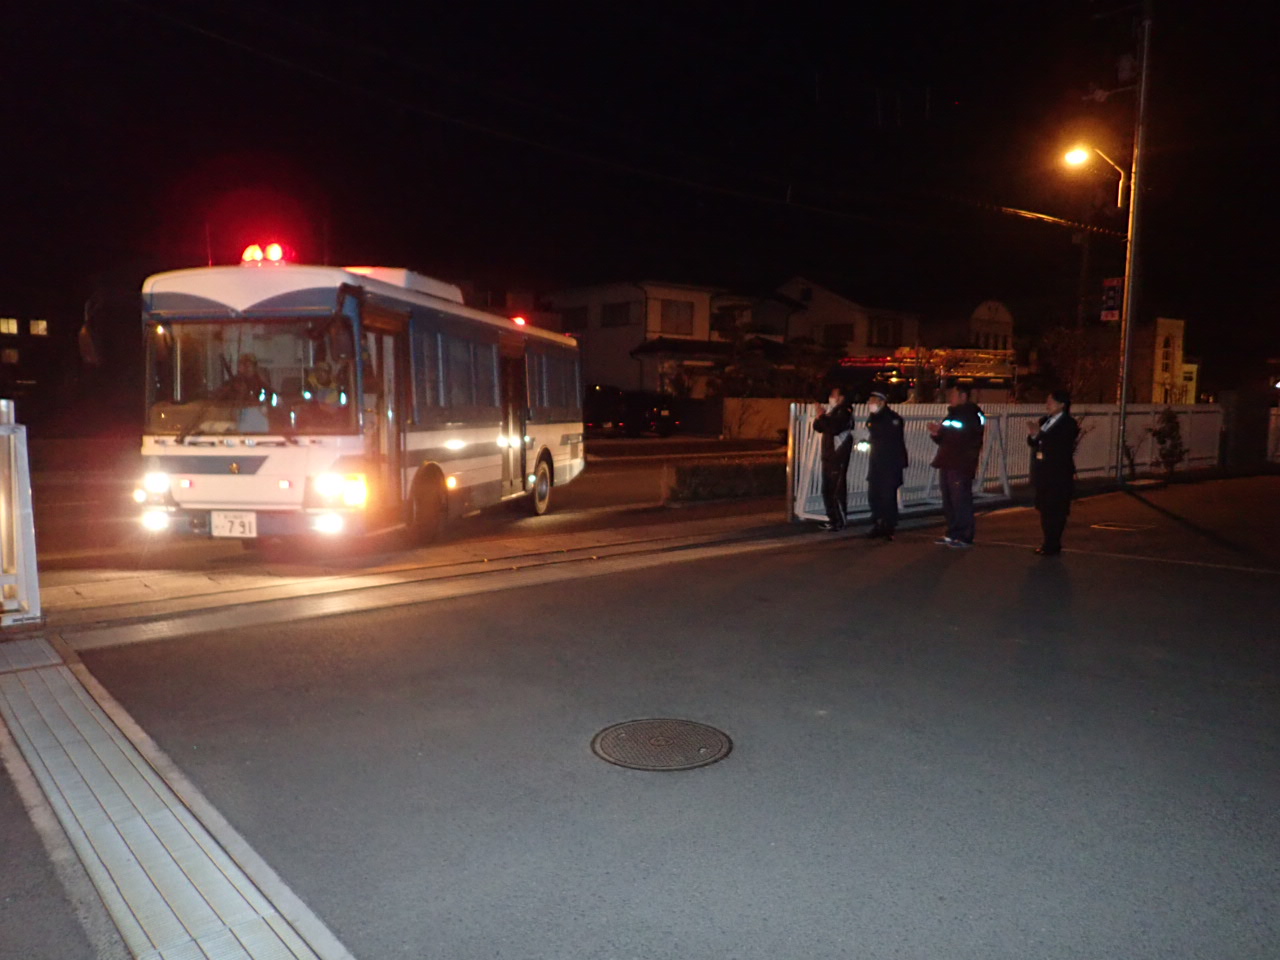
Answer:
xmin=147 ymin=316 xmax=358 ymax=438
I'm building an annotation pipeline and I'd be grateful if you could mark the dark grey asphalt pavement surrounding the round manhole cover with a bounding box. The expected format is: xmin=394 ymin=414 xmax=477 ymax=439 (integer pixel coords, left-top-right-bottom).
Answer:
xmin=74 ymin=477 xmax=1280 ymax=960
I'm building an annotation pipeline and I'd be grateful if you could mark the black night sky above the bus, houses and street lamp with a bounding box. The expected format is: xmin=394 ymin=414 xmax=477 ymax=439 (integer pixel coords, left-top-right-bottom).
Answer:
xmin=0 ymin=0 xmax=1280 ymax=384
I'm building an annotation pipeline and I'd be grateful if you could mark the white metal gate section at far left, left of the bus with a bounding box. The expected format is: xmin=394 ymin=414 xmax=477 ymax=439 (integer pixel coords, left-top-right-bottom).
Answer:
xmin=0 ymin=401 xmax=41 ymax=627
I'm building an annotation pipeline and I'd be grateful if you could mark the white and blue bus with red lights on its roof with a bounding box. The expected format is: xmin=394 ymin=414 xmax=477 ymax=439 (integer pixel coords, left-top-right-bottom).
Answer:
xmin=133 ymin=252 xmax=585 ymax=541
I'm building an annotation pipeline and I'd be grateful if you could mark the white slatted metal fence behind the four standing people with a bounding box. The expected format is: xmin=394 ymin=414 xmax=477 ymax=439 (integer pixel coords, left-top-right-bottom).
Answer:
xmin=787 ymin=403 xmax=1218 ymax=520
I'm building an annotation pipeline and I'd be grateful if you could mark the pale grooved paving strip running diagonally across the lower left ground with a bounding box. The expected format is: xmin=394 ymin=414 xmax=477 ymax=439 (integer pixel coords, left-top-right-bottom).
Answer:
xmin=0 ymin=639 xmax=351 ymax=960
